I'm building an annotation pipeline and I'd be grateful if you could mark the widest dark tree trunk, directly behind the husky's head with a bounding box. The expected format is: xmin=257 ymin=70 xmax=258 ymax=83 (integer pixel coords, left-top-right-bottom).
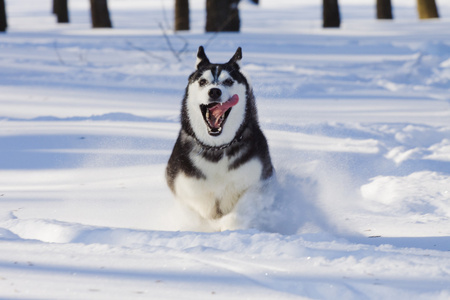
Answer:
xmin=206 ymin=0 xmax=241 ymax=32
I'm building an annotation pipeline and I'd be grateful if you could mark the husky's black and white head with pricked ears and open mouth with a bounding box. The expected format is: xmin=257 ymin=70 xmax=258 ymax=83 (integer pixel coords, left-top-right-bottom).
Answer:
xmin=184 ymin=46 xmax=249 ymax=146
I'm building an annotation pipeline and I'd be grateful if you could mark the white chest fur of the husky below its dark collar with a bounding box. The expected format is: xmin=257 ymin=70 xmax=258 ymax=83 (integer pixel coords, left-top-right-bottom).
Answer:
xmin=174 ymin=154 xmax=262 ymax=219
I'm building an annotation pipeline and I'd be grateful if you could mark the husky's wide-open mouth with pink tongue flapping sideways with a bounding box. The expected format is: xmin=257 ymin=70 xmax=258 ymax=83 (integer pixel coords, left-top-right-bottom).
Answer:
xmin=200 ymin=95 xmax=239 ymax=135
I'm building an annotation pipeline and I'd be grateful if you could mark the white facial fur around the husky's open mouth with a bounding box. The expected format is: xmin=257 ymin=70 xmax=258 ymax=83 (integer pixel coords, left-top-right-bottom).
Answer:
xmin=187 ymin=70 xmax=246 ymax=146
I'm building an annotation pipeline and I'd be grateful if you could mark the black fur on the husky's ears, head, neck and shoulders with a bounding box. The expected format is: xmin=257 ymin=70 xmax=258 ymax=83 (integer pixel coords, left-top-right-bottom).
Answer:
xmin=166 ymin=47 xmax=273 ymax=191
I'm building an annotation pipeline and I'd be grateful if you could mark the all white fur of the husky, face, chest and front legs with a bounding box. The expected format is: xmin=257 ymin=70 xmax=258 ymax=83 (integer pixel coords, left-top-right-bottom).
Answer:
xmin=169 ymin=60 xmax=274 ymax=231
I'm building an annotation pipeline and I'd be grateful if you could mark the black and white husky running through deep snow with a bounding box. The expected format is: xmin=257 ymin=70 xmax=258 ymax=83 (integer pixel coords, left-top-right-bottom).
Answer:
xmin=166 ymin=46 xmax=274 ymax=227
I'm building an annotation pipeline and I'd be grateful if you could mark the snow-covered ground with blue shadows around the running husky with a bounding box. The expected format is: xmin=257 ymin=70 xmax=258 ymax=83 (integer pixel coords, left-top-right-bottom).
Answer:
xmin=0 ymin=0 xmax=450 ymax=300
